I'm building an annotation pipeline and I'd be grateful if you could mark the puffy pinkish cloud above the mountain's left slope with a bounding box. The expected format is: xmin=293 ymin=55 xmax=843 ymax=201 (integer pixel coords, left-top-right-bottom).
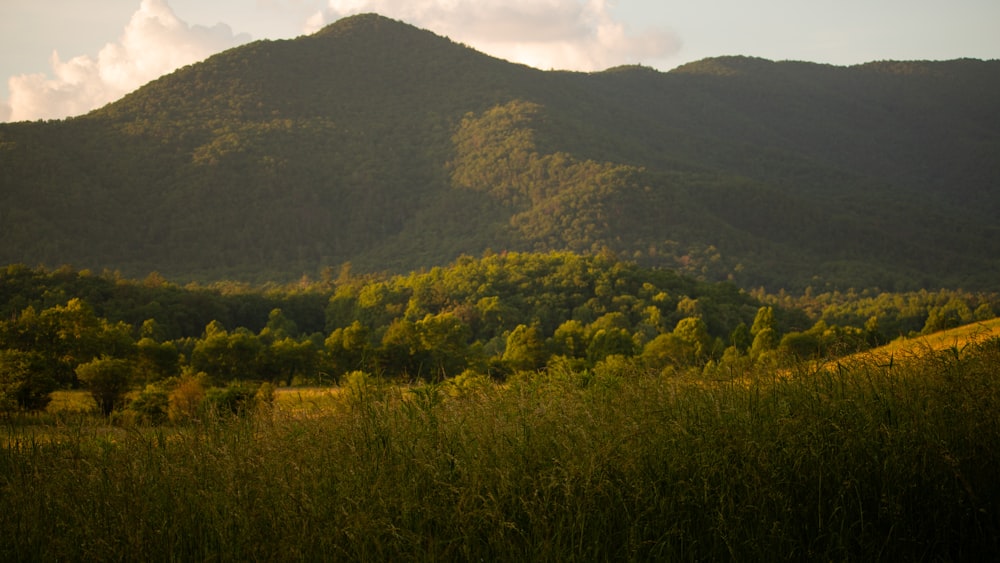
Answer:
xmin=0 ymin=0 xmax=250 ymax=121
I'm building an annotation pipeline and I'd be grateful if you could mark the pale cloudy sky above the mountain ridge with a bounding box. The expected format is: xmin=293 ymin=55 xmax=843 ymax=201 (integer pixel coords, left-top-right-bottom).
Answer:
xmin=0 ymin=0 xmax=1000 ymax=121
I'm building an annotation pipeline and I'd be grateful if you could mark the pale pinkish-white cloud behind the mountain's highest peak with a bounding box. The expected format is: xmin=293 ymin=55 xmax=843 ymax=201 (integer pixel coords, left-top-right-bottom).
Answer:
xmin=306 ymin=0 xmax=680 ymax=71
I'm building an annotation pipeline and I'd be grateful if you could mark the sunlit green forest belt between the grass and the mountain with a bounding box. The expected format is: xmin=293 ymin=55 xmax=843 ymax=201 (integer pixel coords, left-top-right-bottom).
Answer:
xmin=0 ymin=252 xmax=1000 ymax=421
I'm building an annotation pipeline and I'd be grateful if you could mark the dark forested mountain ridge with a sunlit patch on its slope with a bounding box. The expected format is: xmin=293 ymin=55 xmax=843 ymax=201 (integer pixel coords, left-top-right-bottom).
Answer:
xmin=0 ymin=14 xmax=1000 ymax=290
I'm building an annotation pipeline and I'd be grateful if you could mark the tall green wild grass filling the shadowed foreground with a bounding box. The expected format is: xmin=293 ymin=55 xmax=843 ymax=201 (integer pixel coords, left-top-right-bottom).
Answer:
xmin=0 ymin=339 xmax=1000 ymax=561
